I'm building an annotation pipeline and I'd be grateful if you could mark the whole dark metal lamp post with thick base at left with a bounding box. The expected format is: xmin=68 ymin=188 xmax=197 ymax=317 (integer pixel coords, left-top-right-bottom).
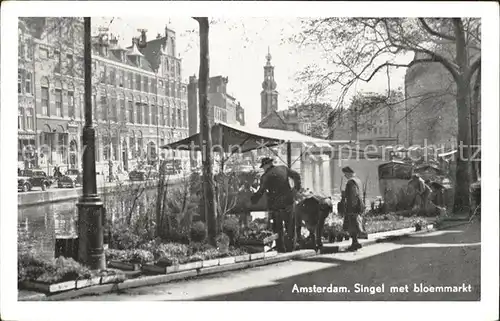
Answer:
xmin=77 ymin=17 xmax=106 ymax=269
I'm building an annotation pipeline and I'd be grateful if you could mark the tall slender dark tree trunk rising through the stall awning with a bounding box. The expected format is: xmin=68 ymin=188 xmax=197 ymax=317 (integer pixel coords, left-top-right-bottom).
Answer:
xmin=195 ymin=17 xmax=217 ymax=246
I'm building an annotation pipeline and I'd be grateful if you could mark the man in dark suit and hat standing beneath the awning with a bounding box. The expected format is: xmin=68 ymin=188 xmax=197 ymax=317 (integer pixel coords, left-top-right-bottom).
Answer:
xmin=251 ymin=157 xmax=302 ymax=252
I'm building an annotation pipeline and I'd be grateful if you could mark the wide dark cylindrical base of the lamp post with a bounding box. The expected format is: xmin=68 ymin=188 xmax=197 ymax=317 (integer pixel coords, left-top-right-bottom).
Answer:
xmin=77 ymin=195 xmax=106 ymax=270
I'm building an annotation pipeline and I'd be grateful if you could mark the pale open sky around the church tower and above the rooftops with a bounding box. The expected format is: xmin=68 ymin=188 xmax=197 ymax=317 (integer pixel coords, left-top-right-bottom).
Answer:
xmin=93 ymin=17 xmax=408 ymax=127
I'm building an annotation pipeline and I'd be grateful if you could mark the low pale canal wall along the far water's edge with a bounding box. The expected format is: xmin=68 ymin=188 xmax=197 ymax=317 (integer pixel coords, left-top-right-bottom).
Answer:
xmin=17 ymin=178 xmax=186 ymax=208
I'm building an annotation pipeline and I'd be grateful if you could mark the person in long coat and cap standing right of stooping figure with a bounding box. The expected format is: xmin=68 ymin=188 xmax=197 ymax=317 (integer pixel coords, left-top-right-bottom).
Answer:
xmin=341 ymin=166 xmax=367 ymax=251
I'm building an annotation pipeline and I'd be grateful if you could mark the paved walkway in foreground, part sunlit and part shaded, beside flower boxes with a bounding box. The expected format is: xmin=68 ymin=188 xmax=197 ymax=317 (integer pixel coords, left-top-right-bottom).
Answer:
xmin=71 ymin=223 xmax=481 ymax=301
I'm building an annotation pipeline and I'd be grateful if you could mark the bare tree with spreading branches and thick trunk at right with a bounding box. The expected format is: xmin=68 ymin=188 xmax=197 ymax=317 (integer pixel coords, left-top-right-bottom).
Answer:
xmin=294 ymin=18 xmax=481 ymax=213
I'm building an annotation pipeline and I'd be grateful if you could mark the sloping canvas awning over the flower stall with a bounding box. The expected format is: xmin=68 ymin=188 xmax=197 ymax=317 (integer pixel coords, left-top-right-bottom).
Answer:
xmin=161 ymin=122 xmax=350 ymax=153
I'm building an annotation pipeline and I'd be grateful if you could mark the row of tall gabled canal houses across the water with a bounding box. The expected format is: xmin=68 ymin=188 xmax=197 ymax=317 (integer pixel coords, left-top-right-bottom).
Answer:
xmin=18 ymin=18 xmax=188 ymax=173
